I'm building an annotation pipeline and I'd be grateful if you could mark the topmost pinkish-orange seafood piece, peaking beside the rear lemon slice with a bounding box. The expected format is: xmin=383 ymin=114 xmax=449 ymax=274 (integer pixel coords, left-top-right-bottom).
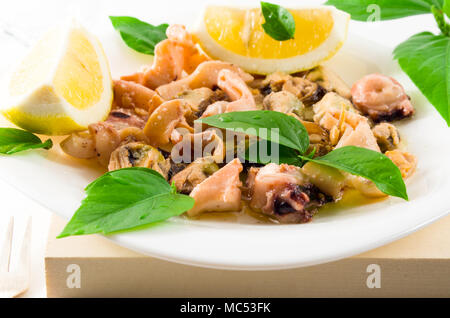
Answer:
xmin=121 ymin=24 xmax=209 ymax=89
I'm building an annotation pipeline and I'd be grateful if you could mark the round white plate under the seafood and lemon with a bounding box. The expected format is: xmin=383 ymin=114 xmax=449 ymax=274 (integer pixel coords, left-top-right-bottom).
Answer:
xmin=0 ymin=13 xmax=450 ymax=270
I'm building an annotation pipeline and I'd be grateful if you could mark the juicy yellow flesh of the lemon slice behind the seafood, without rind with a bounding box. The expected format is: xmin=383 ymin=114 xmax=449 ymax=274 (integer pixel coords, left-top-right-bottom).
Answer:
xmin=204 ymin=7 xmax=334 ymax=59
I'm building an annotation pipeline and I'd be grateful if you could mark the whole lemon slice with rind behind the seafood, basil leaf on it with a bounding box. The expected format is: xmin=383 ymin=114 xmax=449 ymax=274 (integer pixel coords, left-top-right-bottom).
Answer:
xmin=194 ymin=6 xmax=350 ymax=74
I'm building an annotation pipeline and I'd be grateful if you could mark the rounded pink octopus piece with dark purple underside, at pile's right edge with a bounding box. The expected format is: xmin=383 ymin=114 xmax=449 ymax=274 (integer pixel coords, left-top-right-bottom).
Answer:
xmin=352 ymin=74 xmax=414 ymax=122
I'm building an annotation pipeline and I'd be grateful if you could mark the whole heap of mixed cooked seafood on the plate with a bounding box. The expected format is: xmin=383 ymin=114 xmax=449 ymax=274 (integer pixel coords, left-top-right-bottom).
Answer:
xmin=61 ymin=24 xmax=417 ymax=223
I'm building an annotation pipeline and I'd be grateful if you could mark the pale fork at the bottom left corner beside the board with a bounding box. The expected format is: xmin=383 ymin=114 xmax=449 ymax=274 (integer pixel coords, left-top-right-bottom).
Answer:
xmin=0 ymin=217 xmax=31 ymax=298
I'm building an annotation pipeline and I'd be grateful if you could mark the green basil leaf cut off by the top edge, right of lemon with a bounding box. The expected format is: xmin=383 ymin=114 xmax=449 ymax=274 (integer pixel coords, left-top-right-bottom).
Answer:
xmin=325 ymin=0 xmax=443 ymax=21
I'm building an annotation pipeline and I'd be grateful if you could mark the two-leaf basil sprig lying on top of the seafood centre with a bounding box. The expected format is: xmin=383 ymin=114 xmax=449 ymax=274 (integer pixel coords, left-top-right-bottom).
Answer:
xmin=198 ymin=110 xmax=408 ymax=200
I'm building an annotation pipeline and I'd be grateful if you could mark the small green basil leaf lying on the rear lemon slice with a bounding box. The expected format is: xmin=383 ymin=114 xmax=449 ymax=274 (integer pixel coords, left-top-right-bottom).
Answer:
xmin=261 ymin=1 xmax=295 ymax=41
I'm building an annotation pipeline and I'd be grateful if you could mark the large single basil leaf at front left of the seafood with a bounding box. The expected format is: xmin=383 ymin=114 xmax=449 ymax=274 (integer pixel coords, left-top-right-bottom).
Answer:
xmin=58 ymin=168 xmax=194 ymax=238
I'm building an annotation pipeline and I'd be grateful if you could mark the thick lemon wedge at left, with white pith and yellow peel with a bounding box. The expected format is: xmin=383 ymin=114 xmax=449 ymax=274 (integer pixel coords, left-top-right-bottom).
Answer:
xmin=1 ymin=22 xmax=113 ymax=135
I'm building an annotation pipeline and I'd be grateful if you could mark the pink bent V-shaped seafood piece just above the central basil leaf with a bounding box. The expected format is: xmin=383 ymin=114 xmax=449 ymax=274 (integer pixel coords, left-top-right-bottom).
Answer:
xmin=202 ymin=69 xmax=258 ymax=117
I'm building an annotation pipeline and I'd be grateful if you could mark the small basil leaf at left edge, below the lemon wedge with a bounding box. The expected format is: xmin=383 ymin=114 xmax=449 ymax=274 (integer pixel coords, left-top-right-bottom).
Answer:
xmin=0 ymin=128 xmax=53 ymax=155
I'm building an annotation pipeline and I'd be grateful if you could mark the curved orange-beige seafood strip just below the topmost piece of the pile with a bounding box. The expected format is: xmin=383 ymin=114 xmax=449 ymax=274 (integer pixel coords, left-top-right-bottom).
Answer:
xmin=156 ymin=61 xmax=253 ymax=100
